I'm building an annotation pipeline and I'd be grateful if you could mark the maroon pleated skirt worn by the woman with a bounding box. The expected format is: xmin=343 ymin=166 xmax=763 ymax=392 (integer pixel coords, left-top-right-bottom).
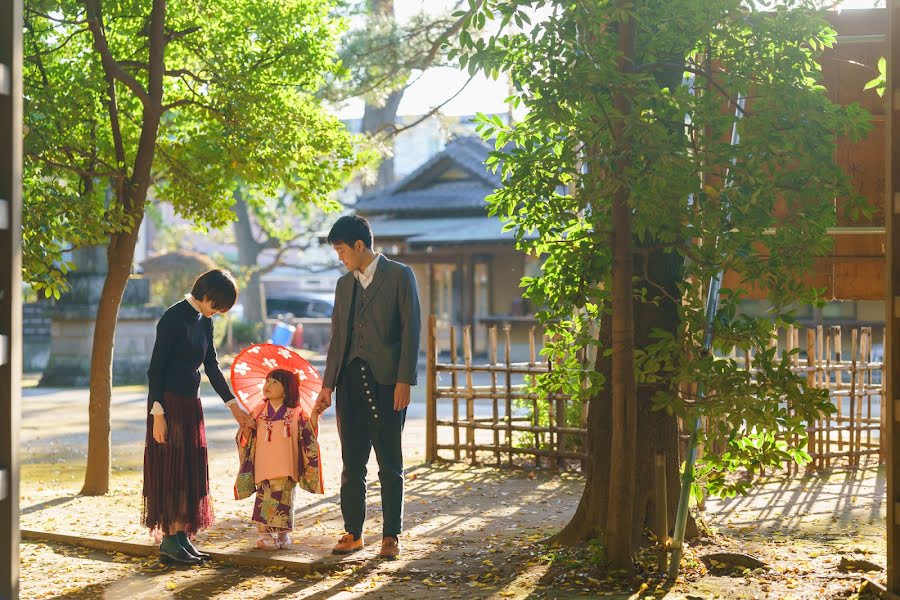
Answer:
xmin=142 ymin=392 xmax=214 ymax=535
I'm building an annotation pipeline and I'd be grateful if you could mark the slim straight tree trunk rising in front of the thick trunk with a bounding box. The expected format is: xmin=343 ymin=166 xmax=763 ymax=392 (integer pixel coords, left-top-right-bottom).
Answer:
xmin=606 ymin=5 xmax=637 ymax=572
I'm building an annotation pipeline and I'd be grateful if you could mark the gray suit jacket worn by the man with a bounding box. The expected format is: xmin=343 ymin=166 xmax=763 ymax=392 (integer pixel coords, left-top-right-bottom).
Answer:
xmin=323 ymin=255 xmax=422 ymax=389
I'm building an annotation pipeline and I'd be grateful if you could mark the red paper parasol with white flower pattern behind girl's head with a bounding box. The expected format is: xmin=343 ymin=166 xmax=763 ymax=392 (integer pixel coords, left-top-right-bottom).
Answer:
xmin=231 ymin=344 xmax=322 ymax=415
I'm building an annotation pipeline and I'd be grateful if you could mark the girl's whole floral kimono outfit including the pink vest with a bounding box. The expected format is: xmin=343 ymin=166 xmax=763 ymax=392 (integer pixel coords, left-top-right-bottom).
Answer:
xmin=234 ymin=402 xmax=325 ymax=532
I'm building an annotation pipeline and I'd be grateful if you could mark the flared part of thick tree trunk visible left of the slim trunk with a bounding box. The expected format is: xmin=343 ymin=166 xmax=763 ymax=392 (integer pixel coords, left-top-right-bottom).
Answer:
xmin=552 ymin=316 xmax=612 ymax=546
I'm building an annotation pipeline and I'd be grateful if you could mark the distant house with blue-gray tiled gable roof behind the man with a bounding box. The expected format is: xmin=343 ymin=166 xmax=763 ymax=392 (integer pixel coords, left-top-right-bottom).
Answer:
xmin=354 ymin=137 xmax=538 ymax=352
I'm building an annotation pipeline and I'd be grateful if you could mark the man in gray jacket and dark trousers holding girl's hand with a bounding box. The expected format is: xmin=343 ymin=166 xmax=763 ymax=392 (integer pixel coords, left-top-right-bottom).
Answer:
xmin=314 ymin=216 xmax=421 ymax=559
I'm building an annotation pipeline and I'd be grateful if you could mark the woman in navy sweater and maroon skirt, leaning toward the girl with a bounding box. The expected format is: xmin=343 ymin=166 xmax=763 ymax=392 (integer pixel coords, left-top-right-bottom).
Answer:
xmin=143 ymin=269 xmax=253 ymax=565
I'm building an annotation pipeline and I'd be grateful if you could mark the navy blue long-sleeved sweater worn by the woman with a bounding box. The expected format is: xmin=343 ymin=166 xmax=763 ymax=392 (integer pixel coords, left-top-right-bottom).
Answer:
xmin=147 ymin=300 xmax=234 ymax=410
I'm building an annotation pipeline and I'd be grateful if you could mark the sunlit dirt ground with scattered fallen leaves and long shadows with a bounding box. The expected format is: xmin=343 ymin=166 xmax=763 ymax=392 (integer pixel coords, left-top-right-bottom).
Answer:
xmin=21 ymin=378 xmax=885 ymax=600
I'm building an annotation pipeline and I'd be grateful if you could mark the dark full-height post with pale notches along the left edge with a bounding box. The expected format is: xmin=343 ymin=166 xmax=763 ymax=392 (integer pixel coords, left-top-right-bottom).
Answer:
xmin=0 ymin=0 xmax=22 ymax=598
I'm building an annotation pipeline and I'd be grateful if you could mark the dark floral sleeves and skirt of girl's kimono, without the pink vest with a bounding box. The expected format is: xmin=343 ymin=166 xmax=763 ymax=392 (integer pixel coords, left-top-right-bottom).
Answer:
xmin=234 ymin=413 xmax=325 ymax=531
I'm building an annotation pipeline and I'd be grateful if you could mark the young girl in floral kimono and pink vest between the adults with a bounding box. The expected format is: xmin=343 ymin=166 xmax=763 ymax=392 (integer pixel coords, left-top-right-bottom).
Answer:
xmin=234 ymin=369 xmax=325 ymax=550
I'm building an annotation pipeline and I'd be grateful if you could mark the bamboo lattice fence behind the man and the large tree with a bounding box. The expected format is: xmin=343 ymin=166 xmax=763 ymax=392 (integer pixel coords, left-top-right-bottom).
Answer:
xmin=426 ymin=315 xmax=885 ymax=469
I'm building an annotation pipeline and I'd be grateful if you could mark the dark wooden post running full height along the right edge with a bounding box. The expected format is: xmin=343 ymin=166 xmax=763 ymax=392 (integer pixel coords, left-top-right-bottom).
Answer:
xmin=884 ymin=0 xmax=900 ymax=597
